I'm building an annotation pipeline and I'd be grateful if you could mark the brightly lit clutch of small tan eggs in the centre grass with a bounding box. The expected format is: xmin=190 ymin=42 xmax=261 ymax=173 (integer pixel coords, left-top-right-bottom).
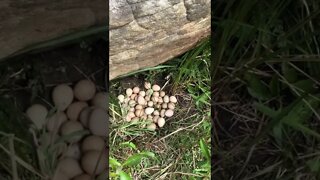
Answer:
xmin=118 ymin=82 xmax=177 ymax=131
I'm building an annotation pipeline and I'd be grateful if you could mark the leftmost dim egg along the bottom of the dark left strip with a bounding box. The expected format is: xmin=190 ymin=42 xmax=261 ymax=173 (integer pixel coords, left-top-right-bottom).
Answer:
xmin=57 ymin=158 xmax=83 ymax=179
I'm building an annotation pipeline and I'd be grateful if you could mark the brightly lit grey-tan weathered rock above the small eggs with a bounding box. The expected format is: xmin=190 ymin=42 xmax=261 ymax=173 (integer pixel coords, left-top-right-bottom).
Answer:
xmin=109 ymin=0 xmax=211 ymax=79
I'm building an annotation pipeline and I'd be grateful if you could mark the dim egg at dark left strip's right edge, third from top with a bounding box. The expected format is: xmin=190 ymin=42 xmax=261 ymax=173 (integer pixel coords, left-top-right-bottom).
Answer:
xmin=81 ymin=135 xmax=106 ymax=152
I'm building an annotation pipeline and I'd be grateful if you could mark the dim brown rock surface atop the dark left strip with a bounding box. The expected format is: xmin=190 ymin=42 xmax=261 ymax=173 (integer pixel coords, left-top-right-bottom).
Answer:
xmin=0 ymin=0 xmax=108 ymax=59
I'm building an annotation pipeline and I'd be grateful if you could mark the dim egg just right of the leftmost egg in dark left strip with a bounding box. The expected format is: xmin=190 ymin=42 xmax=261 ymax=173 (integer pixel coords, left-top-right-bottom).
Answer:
xmin=46 ymin=111 xmax=68 ymax=132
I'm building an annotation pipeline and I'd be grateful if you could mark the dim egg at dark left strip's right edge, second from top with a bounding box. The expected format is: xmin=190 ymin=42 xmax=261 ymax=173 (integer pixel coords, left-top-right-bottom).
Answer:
xmin=88 ymin=108 xmax=108 ymax=136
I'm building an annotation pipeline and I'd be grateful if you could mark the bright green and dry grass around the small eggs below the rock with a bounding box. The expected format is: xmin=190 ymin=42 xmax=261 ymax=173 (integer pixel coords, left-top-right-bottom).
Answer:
xmin=109 ymin=39 xmax=211 ymax=179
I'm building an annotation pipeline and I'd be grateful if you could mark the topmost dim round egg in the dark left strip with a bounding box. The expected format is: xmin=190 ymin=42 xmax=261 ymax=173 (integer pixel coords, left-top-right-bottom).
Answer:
xmin=73 ymin=79 xmax=96 ymax=101
